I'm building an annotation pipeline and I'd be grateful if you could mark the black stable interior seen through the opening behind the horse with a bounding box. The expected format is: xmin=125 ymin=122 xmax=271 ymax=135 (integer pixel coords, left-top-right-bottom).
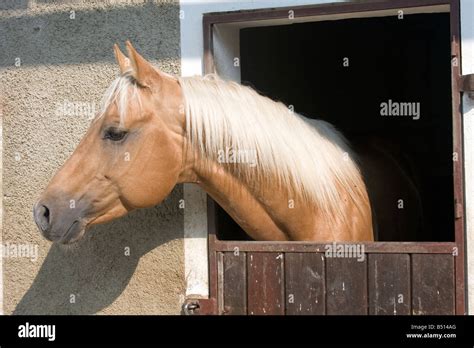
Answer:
xmin=217 ymin=13 xmax=454 ymax=241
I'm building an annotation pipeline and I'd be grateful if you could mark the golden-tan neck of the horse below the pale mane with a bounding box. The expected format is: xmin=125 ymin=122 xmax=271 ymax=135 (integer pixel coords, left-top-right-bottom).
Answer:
xmin=176 ymin=132 xmax=372 ymax=241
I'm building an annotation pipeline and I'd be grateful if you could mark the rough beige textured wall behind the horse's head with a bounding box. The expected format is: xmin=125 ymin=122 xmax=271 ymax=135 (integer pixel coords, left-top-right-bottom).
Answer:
xmin=0 ymin=0 xmax=184 ymax=314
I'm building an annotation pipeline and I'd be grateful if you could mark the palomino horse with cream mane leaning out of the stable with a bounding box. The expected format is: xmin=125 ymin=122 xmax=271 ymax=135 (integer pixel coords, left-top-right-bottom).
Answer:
xmin=34 ymin=42 xmax=418 ymax=244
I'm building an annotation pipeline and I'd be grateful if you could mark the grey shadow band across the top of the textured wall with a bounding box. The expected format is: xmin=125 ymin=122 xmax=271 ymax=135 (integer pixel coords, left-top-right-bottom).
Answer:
xmin=0 ymin=0 xmax=180 ymax=67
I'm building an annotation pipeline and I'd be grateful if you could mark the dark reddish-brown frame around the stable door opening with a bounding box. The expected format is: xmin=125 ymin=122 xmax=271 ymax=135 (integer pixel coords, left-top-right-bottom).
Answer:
xmin=201 ymin=0 xmax=467 ymax=314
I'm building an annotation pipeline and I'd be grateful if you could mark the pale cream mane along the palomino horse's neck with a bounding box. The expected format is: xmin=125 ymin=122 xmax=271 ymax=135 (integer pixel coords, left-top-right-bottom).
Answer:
xmin=179 ymin=74 xmax=367 ymax=219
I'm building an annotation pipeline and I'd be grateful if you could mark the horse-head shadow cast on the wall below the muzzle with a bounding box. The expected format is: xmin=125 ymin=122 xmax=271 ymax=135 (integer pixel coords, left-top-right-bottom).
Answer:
xmin=13 ymin=185 xmax=183 ymax=314
